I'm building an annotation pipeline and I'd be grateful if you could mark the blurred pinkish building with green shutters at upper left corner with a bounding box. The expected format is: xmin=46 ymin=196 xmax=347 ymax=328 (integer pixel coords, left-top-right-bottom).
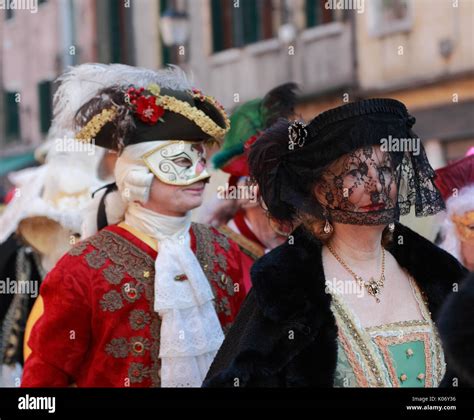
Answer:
xmin=0 ymin=0 xmax=134 ymax=189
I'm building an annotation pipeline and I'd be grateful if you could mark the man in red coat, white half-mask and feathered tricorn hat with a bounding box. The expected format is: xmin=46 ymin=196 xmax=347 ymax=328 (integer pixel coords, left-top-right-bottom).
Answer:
xmin=22 ymin=64 xmax=244 ymax=387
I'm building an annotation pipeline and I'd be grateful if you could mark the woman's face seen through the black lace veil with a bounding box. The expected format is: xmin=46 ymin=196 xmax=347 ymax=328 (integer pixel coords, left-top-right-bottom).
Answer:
xmin=315 ymin=146 xmax=397 ymax=213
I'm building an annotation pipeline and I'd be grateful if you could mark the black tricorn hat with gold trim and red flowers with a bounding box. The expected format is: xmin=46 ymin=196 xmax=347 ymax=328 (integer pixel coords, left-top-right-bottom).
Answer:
xmin=76 ymin=83 xmax=230 ymax=151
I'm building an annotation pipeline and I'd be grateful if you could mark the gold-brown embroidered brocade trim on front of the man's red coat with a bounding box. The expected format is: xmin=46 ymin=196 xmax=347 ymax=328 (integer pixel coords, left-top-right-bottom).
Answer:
xmin=69 ymin=223 xmax=235 ymax=387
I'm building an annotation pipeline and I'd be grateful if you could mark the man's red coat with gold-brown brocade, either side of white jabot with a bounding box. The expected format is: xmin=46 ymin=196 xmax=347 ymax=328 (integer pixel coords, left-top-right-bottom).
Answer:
xmin=22 ymin=224 xmax=245 ymax=387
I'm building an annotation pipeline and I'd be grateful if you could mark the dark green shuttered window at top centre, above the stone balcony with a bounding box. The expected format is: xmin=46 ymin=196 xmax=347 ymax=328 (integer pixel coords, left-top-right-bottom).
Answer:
xmin=211 ymin=0 xmax=275 ymax=52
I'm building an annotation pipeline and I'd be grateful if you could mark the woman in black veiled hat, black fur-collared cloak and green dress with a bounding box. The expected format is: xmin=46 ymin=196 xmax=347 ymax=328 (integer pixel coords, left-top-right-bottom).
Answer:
xmin=205 ymin=99 xmax=466 ymax=387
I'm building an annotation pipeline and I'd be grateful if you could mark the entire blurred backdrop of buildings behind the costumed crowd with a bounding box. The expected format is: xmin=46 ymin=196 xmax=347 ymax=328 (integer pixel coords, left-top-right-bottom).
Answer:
xmin=0 ymin=0 xmax=474 ymax=221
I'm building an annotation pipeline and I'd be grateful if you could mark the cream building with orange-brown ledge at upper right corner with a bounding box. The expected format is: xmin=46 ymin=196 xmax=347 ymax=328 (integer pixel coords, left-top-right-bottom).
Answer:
xmin=356 ymin=0 xmax=474 ymax=168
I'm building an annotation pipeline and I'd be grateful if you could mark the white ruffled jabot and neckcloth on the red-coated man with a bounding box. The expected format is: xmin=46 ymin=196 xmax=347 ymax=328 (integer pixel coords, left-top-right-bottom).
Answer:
xmin=125 ymin=203 xmax=224 ymax=387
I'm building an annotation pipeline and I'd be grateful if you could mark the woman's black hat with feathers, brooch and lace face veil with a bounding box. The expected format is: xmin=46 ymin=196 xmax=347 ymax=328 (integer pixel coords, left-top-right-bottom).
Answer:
xmin=249 ymin=99 xmax=444 ymax=225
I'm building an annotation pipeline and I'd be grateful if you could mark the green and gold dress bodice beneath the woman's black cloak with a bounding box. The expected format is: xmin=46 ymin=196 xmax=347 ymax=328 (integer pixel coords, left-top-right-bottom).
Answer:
xmin=327 ymin=276 xmax=446 ymax=387
